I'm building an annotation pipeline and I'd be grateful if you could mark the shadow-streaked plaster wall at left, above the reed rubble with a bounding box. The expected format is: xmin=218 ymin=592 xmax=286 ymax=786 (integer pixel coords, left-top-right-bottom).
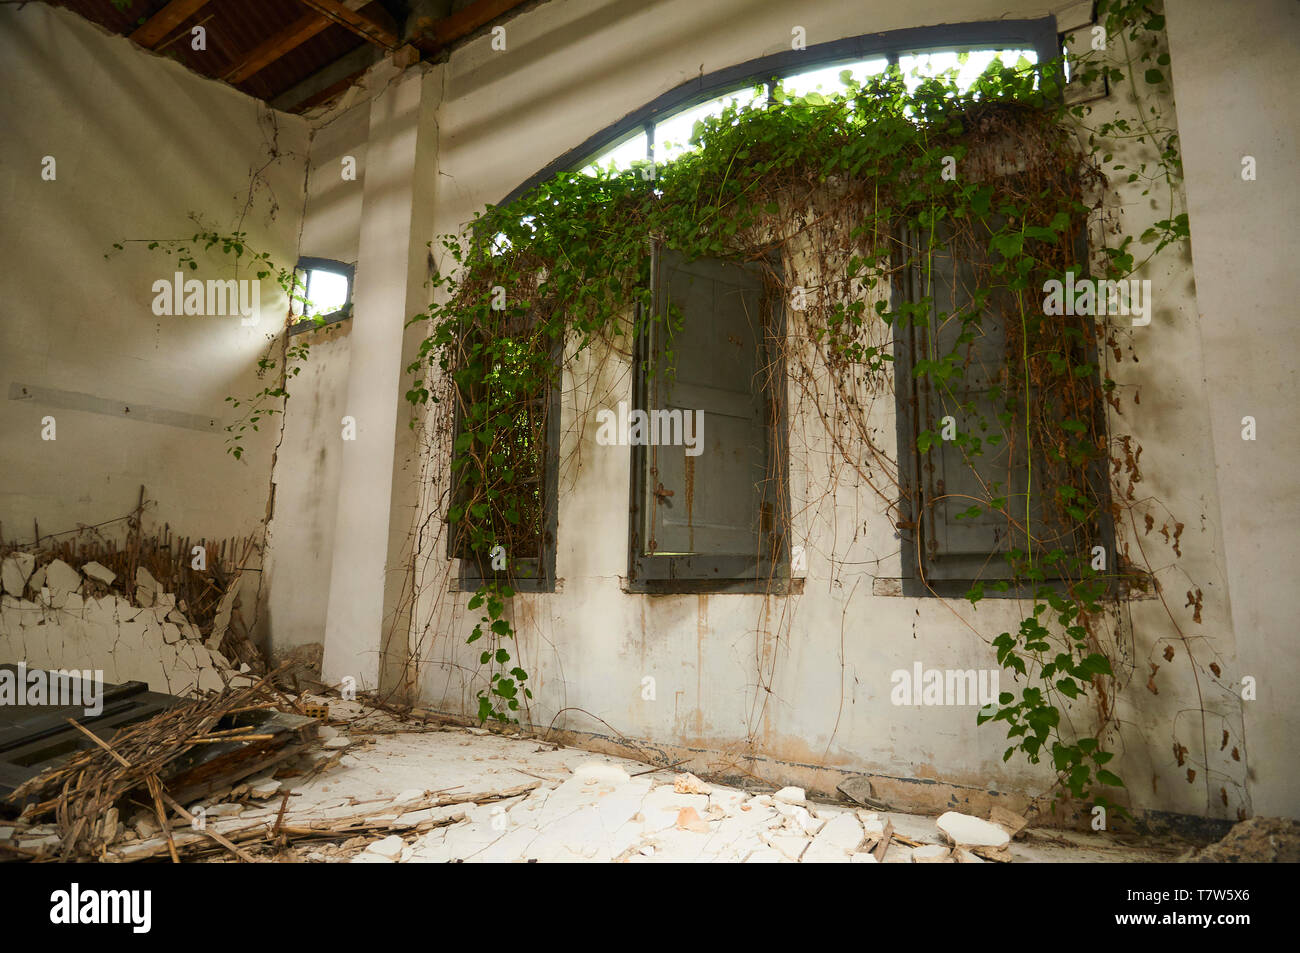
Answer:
xmin=0 ymin=4 xmax=308 ymax=538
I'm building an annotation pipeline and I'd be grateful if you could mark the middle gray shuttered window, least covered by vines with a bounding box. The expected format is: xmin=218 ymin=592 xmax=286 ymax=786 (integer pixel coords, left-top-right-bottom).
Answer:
xmin=620 ymin=248 xmax=789 ymax=592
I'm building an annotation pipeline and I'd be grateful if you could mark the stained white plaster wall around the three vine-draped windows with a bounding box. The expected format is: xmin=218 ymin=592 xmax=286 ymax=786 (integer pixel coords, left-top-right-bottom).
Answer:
xmin=400 ymin=0 xmax=1297 ymax=818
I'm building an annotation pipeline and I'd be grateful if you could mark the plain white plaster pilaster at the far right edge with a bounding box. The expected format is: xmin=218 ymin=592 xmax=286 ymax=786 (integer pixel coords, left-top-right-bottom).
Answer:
xmin=1167 ymin=0 xmax=1300 ymax=816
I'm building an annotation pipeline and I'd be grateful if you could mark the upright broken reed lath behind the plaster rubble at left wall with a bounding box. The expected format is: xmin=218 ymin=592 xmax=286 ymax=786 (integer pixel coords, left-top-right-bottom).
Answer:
xmin=0 ymin=486 xmax=267 ymax=672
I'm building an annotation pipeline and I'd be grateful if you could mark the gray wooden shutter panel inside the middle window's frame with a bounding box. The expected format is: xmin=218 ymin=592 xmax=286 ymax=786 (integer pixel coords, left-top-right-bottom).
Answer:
xmin=642 ymin=250 xmax=770 ymax=556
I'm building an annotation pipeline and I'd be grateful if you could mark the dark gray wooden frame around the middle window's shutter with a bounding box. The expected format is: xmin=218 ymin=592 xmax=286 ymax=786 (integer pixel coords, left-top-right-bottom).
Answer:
xmin=625 ymin=242 xmax=802 ymax=595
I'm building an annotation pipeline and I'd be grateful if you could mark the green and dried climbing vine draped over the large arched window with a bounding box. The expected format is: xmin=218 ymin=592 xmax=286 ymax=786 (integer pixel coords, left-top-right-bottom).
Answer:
xmin=406 ymin=0 xmax=1188 ymax=805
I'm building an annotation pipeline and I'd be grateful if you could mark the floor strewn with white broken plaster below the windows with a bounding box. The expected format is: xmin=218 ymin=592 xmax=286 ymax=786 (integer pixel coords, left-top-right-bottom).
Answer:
xmin=0 ymin=698 xmax=1188 ymax=863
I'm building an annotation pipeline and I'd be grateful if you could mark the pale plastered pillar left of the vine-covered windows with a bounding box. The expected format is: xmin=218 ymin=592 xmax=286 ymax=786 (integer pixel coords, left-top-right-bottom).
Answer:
xmin=322 ymin=66 xmax=442 ymax=690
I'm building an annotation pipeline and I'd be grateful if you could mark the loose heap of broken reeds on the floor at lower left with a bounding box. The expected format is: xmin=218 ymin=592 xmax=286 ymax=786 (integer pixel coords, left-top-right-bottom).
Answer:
xmin=9 ymin=666 xmax=296 ymax=861
